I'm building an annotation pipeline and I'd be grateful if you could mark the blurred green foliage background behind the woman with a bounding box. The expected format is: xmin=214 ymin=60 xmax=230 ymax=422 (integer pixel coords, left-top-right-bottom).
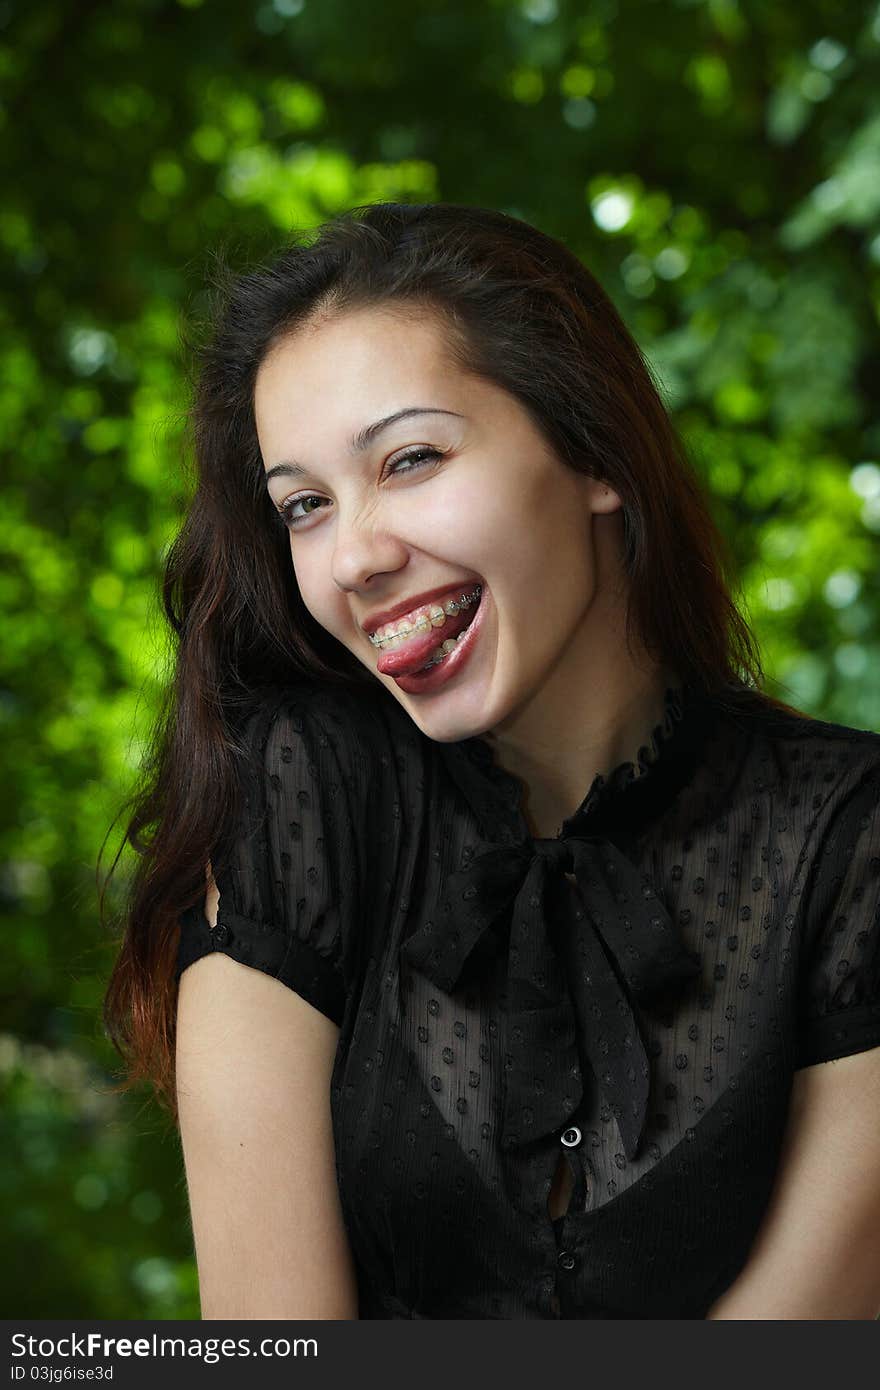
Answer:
xmin=0 ymin=0 xmax=880 ymax=1318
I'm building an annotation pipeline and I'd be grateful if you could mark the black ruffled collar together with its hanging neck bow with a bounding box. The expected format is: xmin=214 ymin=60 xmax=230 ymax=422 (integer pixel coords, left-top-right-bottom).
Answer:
xmin=400 ymin=687 xmax=712 ymax=1158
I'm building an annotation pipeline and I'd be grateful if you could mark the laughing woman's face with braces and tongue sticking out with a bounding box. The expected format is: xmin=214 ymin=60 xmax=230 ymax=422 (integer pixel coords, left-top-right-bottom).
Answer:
xmin=254 ymin=309 xmax=620 ymax=742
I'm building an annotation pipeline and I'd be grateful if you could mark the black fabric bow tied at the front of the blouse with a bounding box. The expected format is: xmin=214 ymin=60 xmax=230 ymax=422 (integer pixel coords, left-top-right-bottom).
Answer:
xmin=402 ymin=837 xmax=699 ymax=1158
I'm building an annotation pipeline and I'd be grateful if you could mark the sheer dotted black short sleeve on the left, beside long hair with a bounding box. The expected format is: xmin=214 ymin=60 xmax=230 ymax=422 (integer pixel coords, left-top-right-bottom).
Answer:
xmin=177 ymin=689 xmax=361 ymax=1024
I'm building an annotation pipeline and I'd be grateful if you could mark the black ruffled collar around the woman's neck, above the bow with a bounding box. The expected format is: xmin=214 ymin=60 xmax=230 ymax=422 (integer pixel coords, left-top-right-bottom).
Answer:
xmin=439 ymin=681 xmax=713 ymax=844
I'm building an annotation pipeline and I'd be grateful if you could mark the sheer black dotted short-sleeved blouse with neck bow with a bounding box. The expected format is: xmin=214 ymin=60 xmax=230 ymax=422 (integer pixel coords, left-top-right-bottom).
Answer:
xmin=178 ymin=681 xmax=880 ymax=1319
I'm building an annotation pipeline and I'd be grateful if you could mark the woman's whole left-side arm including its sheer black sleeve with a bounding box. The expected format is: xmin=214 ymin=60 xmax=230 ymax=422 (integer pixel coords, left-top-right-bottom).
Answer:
xmin=177 ymin=688 xmax=386 ymax=1318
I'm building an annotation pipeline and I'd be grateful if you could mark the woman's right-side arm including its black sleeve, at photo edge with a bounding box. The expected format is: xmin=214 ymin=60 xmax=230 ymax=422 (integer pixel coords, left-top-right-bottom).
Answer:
xmin=709 ymin=746 xmax=880 ymax=1319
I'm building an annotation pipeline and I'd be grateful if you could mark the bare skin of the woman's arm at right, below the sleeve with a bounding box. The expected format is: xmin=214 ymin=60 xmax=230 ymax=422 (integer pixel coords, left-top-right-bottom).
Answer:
xmin=706 ymin=1047 xmax=880 ymax=1321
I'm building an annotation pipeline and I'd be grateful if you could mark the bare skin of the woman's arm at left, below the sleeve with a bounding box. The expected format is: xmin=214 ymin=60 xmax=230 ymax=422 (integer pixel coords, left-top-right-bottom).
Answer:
xmin=177 ymin=872 xmax=357 ymax=1319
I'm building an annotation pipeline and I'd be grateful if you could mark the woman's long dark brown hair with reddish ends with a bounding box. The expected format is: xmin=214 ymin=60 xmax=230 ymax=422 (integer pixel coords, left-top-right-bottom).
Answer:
xmin=101 ymin=203 xmax=797 ymax=1115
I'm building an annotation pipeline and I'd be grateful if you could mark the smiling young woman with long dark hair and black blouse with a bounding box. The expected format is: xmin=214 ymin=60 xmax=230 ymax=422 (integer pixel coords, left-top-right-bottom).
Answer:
xmin=107 ymin=204 xmax=880 ymax=1319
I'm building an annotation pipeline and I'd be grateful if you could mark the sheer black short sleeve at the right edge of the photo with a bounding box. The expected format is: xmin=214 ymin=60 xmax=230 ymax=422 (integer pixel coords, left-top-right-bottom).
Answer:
xmin=797 ymin=758 xmax=880 ymax=1066
